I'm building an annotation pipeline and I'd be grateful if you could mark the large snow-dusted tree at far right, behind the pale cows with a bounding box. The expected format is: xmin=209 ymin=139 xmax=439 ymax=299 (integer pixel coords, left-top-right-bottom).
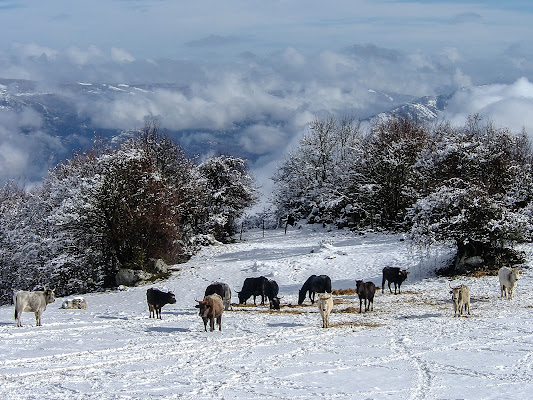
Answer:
xmin=408 ymin=116 xmax=533 ymax=271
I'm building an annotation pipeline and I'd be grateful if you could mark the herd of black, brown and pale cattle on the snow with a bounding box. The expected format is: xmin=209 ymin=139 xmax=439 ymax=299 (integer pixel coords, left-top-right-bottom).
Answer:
xmin=13 ymin=267 xmax=519 ymax=332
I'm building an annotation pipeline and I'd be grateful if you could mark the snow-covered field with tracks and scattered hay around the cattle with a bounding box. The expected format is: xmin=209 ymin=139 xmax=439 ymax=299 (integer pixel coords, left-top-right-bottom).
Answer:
xmin=0 ymin=228 xmax=533 ymax=399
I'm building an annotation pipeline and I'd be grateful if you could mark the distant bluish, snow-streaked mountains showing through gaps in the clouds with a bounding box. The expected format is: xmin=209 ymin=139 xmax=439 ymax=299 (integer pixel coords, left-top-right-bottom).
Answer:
xmin=0 ymin=79 xmax=451 ymax=183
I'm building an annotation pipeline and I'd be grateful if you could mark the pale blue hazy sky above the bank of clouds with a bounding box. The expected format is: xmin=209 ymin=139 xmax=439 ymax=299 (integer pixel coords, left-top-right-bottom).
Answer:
xmin=0 ymin=0 xmax=533 ymax=69
